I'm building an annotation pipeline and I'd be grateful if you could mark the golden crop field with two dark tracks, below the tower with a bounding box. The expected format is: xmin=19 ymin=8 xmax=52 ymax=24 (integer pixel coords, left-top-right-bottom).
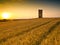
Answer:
xmin=0 ymin=18 xmax=60 ymax=45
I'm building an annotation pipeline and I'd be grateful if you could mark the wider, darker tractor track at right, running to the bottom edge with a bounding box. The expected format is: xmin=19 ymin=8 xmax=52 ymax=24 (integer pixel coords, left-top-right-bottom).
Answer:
xmin=32 ymin=22 xmax=60 ymax=45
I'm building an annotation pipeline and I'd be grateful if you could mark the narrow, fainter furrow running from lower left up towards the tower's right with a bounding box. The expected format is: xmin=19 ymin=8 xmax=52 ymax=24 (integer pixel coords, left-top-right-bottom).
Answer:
xmin=0 ymin=21 xmax=50 ymax=43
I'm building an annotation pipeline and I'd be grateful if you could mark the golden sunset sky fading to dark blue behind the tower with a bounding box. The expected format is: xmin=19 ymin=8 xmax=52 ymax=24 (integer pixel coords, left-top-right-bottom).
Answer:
xmin=0 ymin=0 xmax=60 ymax=19
